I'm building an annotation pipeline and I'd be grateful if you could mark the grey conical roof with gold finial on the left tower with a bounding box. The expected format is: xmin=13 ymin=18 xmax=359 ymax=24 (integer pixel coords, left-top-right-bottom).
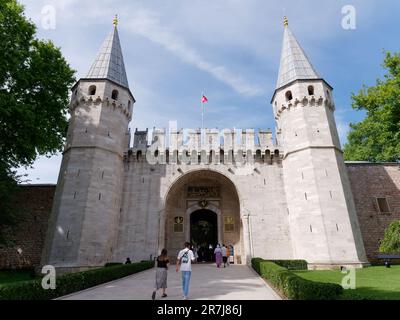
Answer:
xmin=86 ymin=17 xmax=129 ymax=88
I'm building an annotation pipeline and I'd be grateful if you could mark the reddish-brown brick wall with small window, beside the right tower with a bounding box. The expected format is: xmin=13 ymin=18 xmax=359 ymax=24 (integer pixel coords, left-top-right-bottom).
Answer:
xmin=346 ymin=163 xmax=400 ymax=264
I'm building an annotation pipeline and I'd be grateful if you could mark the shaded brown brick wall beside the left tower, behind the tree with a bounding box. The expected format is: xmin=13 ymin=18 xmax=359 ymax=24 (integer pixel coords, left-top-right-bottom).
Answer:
xmin=0 ymin=185 xmax=55 ymax=269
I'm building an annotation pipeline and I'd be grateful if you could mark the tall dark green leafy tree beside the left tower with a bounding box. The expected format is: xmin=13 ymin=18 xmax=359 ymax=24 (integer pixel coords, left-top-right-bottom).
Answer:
xmin=0 ymin=0 xmax=75 ymax=235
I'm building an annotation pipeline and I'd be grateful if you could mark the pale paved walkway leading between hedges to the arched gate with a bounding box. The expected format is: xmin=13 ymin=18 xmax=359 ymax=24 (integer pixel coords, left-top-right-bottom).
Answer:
xmin=61 ymin=264 xmax=280 ymax=300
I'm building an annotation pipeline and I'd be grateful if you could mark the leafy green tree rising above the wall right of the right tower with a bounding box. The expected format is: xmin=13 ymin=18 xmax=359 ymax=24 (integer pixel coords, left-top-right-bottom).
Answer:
xmin=344 ymin=52 xmax=400 ymax=162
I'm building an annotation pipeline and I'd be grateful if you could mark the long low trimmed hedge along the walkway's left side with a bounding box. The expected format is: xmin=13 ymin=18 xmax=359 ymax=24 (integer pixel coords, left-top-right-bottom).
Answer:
xmin=0 ymin=261 xmax=154 ymax=300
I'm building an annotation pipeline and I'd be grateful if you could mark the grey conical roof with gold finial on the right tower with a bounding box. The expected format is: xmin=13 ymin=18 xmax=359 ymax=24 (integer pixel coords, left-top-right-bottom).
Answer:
xmin=276 ymin=17 xmax=320 ymax=89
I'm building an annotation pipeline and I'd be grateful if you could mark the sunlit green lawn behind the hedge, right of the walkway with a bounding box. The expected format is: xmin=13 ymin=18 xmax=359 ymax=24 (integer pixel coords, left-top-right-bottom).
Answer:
xmin=292 ymin=266 xmax=400 ymax=300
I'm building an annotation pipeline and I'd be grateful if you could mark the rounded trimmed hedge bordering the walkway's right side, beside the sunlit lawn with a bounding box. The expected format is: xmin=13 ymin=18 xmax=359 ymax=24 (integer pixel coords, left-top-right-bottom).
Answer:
xmin=251 ymin=258 xmax=343 ymax=300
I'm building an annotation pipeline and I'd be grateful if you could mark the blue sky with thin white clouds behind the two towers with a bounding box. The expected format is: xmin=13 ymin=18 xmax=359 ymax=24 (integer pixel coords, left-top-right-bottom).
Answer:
xmin=19 ymin=0 xmax=400 ymax=183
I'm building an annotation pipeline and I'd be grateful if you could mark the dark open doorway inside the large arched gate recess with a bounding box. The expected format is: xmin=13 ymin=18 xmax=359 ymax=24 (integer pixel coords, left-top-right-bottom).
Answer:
xmin=190 ymin=209 xmax=218 ymax=262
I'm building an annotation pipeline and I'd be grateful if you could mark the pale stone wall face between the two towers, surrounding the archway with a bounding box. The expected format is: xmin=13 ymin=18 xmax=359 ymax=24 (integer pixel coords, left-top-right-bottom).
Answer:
xmin=114 ymin=158 xmax=293 ymax=263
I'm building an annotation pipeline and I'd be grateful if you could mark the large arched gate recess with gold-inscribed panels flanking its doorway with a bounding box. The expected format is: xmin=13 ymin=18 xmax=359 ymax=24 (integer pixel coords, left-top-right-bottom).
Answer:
xmin=159 ymin=169 xmax=244 ymax=263
